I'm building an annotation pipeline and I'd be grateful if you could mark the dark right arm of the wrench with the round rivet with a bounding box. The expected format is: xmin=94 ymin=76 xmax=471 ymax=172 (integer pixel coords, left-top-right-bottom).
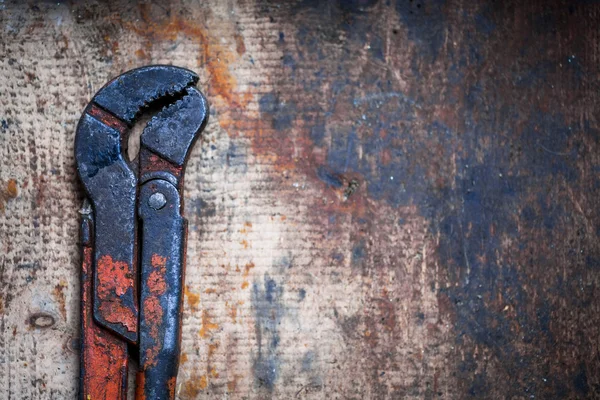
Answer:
xmin=136 ymin=179 xmax=187 ymax=400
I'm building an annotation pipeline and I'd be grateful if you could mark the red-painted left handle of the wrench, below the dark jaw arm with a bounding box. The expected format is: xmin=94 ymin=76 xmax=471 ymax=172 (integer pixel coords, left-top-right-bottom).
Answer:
xmin=81 ymin=247 xmax=127 ymax=400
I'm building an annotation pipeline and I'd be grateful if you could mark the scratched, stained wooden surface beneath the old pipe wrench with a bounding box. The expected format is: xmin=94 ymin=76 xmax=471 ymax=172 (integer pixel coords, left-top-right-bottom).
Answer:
xmin=0 ymin=0 xmax=600 ymax=399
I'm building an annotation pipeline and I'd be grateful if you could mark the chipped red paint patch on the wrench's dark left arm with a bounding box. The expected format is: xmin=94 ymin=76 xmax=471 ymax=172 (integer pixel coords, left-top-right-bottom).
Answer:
xmin=96 ymin=255 xmax=137 ymax=332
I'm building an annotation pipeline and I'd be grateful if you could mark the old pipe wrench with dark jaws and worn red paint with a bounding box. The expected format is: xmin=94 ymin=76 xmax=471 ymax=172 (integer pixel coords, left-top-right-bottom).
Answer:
xmin=75 ymin=66 xmax=208 ymax=400
